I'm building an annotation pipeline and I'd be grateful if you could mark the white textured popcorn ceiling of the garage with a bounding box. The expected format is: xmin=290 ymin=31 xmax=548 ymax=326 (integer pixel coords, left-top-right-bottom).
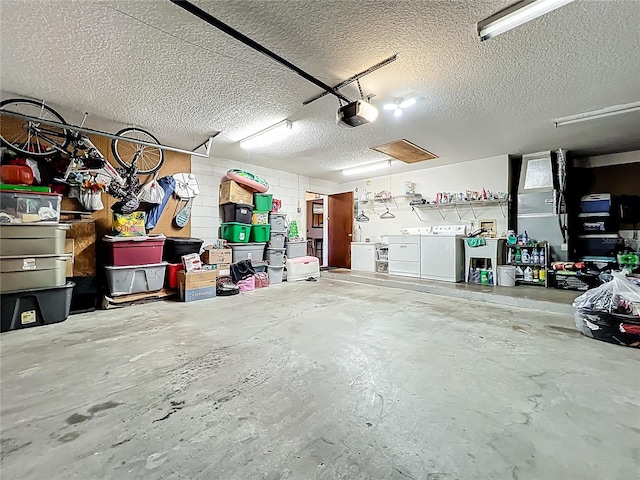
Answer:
xmin=0 ymin=0 xmax=640 ymax=181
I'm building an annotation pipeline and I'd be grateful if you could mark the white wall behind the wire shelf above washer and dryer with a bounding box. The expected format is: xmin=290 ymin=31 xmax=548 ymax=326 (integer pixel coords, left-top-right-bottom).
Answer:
xmin=341 ymin=155 xmax=509 ymax=241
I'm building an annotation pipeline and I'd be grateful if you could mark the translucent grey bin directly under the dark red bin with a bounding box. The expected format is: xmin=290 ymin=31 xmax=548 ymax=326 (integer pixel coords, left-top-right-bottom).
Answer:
xmin=104 ymin=262 xmax=167 ymax=296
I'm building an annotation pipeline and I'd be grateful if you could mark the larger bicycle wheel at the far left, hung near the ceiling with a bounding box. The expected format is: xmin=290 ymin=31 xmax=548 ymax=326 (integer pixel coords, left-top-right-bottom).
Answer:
xmin=0 ymin=98 xmax=69 ymax=157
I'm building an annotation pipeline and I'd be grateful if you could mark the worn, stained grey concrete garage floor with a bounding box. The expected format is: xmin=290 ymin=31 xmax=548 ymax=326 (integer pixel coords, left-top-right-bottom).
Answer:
xmin=0 ymin=278 xmax=640 ymax=480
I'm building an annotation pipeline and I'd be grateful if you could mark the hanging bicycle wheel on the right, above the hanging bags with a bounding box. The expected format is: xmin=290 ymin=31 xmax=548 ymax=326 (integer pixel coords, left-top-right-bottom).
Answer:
xmin=111 ymin=127 xmax=164 ymax=175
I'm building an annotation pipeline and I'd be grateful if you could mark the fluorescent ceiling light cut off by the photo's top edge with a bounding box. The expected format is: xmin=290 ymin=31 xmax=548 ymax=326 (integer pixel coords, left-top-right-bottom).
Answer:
xmin=478 ymin=0 xmax=573 ymax=40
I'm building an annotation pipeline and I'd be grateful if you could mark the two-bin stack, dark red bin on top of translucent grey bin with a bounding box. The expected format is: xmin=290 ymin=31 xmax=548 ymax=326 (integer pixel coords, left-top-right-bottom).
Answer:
xmin=103 ymin=235 xmax=167 ymax=296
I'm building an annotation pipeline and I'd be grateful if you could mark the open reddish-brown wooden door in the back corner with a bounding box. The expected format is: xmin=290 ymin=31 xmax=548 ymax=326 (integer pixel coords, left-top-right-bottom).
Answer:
xmin=327 ymin=192 xmax=353 ymax=268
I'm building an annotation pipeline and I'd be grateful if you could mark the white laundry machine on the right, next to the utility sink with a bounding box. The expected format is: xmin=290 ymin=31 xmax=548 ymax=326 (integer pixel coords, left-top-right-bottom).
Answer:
xmin=420 ymin=225 xmax=467 ymax=282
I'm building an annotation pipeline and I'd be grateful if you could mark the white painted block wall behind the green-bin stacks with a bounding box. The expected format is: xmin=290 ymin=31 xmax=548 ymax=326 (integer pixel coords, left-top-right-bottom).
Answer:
xmin=191 ymin=156 xmax=341 ymax=245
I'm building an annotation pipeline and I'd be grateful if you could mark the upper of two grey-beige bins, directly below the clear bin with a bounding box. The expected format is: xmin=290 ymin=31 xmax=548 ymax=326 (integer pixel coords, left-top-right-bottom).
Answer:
xmin=0 ymin=224 xmax=71 ymax=257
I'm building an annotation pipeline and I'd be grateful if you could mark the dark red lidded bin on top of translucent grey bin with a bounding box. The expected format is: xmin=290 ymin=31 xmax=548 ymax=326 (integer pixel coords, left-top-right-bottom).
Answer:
xmin=104 ymin=237 xmax=165 ymax=267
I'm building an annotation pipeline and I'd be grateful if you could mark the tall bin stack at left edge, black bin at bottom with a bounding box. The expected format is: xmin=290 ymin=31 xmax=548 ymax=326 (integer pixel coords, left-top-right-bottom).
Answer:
xmin=0 ymin=191 xmax=75 ymax=332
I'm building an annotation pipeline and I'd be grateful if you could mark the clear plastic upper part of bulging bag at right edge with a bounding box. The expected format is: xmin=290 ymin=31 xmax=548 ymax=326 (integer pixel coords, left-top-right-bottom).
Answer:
xmin=573 ymin=272 xmax=640 ymax=317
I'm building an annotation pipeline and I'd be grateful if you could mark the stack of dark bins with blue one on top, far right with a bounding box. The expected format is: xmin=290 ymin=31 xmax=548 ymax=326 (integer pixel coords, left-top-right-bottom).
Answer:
xmin=578 ymin=193 xmax=621 ymax=263
